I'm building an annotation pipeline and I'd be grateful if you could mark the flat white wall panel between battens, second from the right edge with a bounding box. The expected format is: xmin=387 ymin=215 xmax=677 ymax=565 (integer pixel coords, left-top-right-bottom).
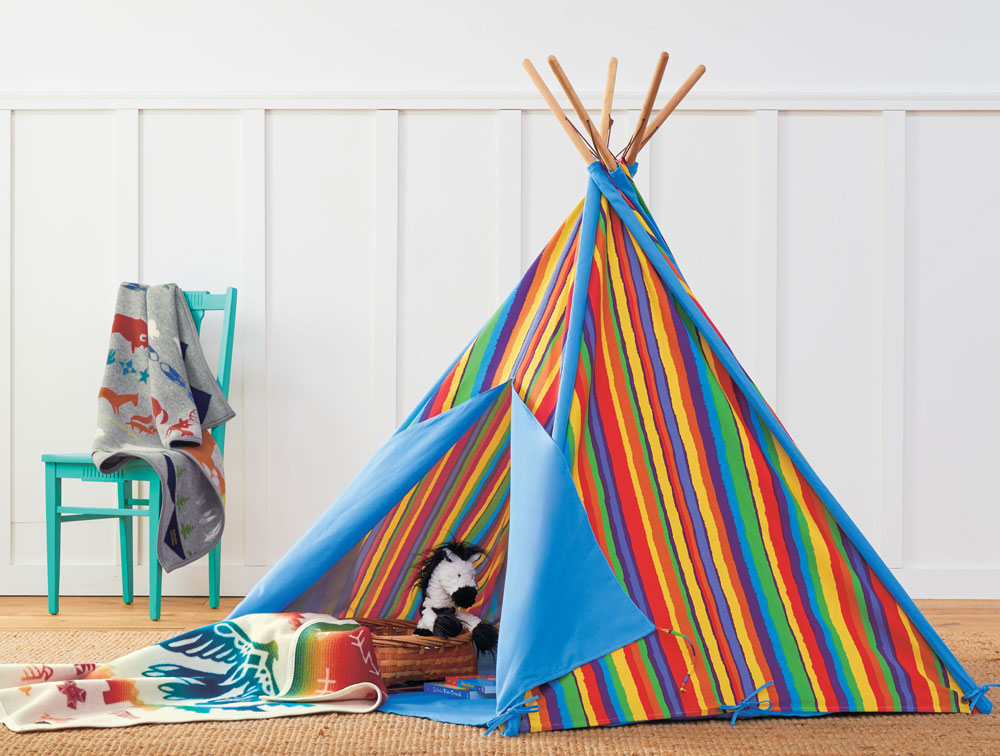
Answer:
xmin=776 ymin=113 xmax=882 ymax=543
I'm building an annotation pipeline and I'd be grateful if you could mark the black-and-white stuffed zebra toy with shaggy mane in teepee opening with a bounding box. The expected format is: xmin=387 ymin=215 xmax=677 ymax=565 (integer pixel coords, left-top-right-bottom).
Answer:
xmin=413 ymin=541 xmax=498 ymax=654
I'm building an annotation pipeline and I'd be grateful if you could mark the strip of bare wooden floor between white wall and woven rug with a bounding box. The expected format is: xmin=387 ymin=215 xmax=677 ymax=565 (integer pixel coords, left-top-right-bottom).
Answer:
xmin=0 ymin=596 xmax=1000 ymax=632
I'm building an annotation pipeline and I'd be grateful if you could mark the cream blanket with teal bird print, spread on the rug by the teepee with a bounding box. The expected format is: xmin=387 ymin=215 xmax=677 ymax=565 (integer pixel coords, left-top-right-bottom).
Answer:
xmin=0 ymin=613 xmax=386 ymax=732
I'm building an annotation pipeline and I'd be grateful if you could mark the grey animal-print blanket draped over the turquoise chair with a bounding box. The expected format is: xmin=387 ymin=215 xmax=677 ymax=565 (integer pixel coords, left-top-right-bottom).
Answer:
xmin=93 ymin=283 xmax=236 ymax=572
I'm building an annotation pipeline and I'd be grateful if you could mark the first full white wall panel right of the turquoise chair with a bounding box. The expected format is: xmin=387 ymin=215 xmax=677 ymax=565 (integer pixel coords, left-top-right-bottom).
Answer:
xmin=262 ymin=111 xmax=378 ymax=564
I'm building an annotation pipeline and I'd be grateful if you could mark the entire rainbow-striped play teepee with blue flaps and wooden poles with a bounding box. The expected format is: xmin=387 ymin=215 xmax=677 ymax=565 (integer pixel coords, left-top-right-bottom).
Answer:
xmin=234 ymin=54 xmax=990 ymax=734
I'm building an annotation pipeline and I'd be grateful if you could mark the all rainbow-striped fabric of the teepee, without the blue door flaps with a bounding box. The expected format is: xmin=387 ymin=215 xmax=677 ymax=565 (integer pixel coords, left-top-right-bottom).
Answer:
xmin=236 ymin=163 xmax=989 ymax=731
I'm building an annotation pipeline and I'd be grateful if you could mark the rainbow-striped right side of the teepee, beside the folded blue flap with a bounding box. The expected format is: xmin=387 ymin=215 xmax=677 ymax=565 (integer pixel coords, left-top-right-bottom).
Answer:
xmin=527 ymin=180 xmax=964 ymax=730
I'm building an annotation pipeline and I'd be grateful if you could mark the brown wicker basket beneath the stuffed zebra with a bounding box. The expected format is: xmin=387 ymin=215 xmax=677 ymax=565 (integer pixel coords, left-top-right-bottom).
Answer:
xmin=354 ymin=617 xmax=478 ymax=685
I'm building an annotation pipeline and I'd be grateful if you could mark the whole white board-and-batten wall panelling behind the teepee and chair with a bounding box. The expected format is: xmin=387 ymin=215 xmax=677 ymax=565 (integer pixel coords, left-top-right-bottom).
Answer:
xmin=0 ymin=95 xmax=1000 ymax=597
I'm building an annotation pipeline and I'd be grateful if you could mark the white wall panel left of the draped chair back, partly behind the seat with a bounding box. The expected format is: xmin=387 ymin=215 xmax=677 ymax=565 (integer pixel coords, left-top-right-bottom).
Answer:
xmin=9 ymin=110 xmax=115 ymax=568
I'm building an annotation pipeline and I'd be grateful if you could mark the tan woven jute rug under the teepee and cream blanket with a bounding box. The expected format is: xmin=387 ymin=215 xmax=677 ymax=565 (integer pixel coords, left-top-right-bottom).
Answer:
xmin=0 ymin=629 xmax=1000 ymax=756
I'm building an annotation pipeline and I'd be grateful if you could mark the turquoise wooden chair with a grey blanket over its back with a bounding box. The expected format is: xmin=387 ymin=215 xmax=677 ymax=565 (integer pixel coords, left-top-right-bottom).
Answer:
xmin=42 ymin=287 xmax=236 ymax=620
